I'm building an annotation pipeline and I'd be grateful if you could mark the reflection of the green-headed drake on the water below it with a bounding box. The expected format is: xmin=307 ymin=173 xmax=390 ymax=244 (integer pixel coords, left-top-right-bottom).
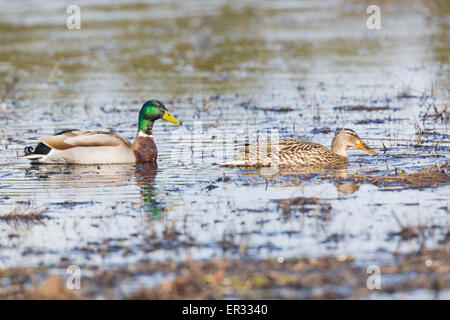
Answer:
xmin=25 ymin=163 xmax=165 ymax=219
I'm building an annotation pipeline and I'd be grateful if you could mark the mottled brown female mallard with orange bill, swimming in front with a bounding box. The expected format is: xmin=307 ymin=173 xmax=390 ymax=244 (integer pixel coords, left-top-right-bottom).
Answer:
xmin=221 ymin=129 xmax=376 ymax=167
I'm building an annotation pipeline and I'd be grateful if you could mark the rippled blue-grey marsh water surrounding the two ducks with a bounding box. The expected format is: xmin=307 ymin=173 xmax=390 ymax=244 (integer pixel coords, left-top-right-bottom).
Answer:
xmin=0 ymin=0 xmax=450 ymax=298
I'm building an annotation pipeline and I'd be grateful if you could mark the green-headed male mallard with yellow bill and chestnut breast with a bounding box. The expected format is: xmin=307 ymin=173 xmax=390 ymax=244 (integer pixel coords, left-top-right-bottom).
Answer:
xmin=23 ymin=100 xmax=181 ymax=164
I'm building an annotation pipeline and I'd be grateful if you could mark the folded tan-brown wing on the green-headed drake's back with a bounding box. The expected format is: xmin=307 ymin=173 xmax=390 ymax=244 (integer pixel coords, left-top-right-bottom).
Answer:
xmin=39 ymin=130 xmax=131 ymax=150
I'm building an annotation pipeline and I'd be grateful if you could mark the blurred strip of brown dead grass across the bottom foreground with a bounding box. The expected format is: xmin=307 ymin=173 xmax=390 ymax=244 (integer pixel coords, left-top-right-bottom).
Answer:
xmin=0 ymin=244 xmax=450 ymax=299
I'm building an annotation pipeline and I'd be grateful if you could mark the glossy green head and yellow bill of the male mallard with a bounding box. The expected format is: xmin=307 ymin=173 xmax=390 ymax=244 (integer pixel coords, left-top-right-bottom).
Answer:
xmin=139 ymin=100 xmax=182 ymax=134
